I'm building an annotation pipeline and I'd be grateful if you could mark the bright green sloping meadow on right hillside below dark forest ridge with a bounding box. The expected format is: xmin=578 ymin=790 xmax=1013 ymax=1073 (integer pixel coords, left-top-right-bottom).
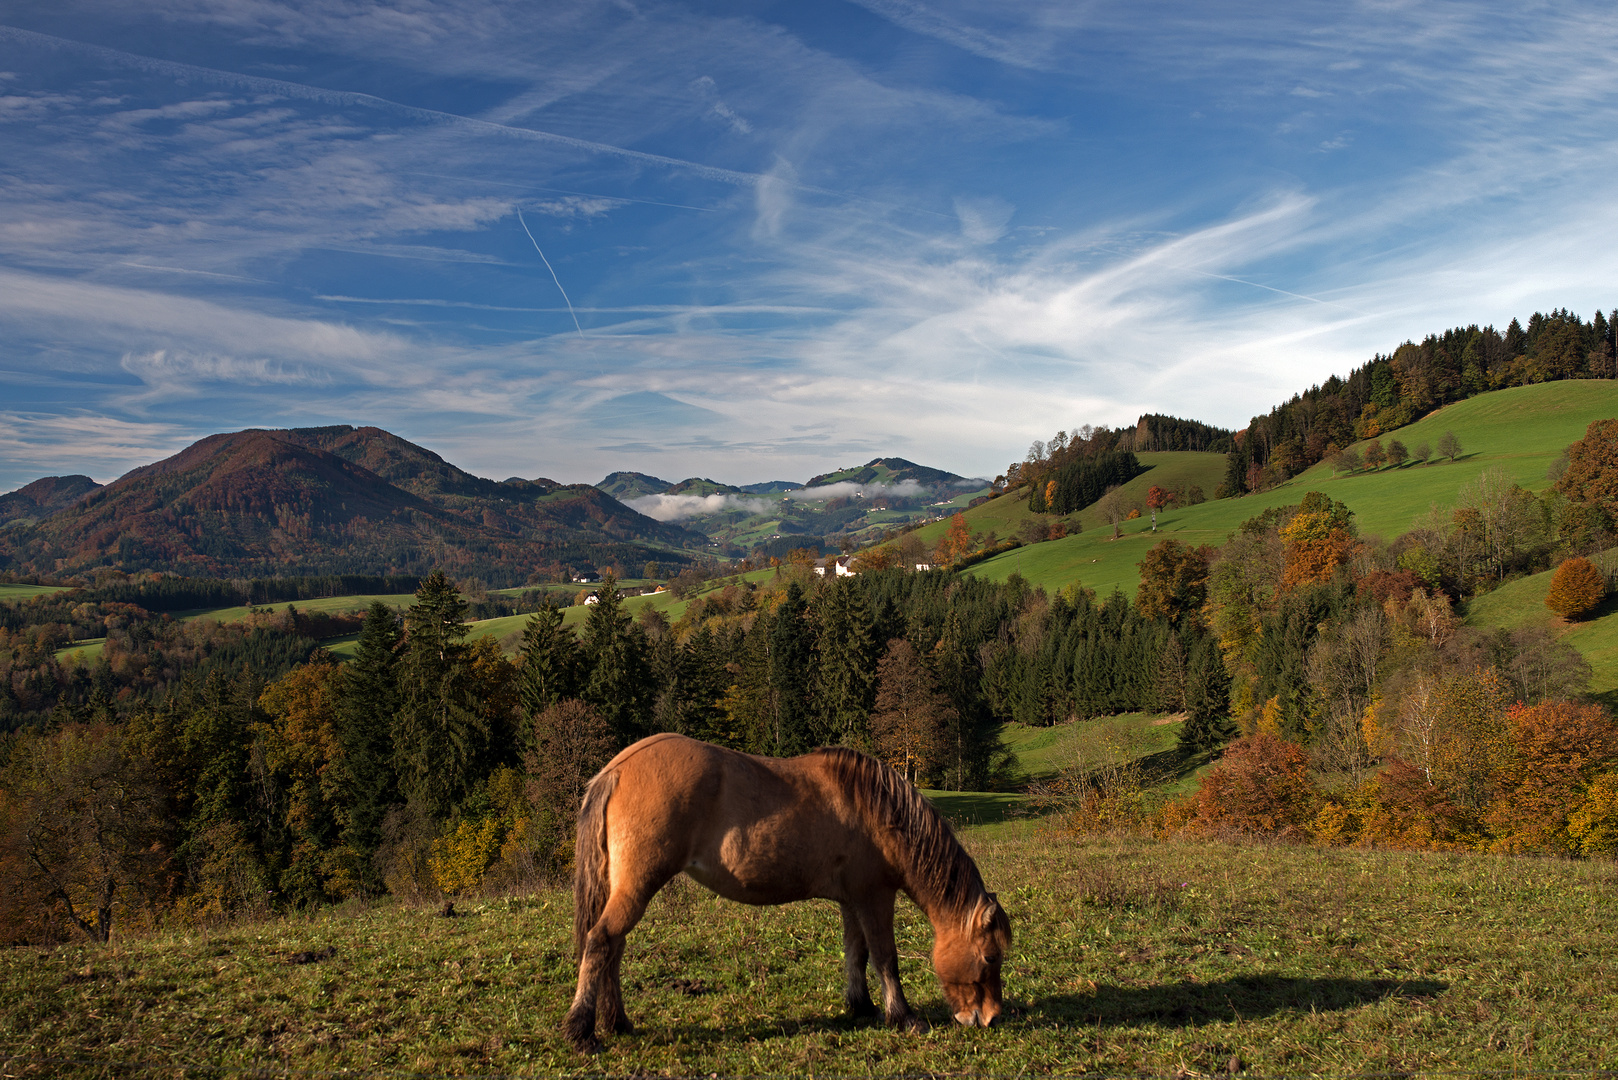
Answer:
xmin=968 ymin=381 xmax=1618 ymax=596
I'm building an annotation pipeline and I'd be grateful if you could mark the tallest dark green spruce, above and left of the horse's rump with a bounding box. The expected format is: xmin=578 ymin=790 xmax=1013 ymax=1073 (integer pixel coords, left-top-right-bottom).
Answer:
xmin=393 ymin=570 xmax=489 ymax=821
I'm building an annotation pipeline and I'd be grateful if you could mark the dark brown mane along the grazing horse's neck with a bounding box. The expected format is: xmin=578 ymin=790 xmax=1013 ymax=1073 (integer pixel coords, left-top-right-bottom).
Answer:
xmin=812 ymin=746 xmax=984 ymax=910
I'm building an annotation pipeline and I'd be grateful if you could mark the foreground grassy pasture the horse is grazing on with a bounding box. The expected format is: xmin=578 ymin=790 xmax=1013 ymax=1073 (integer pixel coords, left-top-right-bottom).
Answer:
xmin=0 ymin=821 xmax=1618 ymax=1077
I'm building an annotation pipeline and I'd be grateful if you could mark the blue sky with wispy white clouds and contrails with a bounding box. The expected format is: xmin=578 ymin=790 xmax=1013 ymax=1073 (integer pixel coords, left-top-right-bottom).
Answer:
xmin=0 ymin=0 xmax=1618 ymax=491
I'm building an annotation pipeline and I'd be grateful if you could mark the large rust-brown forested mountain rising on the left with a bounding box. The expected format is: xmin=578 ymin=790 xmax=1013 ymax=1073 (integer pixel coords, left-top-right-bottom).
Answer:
xmin=0 ymin=426 xmax=704 ymax=583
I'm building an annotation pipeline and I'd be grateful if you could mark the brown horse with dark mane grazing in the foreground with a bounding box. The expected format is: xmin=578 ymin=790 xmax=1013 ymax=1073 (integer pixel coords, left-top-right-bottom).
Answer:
xmin=563 ymin=733 xmax=1011 ymax=1051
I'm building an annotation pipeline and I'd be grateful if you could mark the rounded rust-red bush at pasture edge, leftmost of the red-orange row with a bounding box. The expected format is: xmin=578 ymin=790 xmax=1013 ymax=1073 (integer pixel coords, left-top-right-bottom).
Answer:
xmin=1189 ymin=732 xmax=1315 ymax=836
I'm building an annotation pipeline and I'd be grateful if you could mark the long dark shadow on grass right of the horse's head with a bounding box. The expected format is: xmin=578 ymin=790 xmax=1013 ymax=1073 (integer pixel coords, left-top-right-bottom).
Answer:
xmin=1024 ymin=975 xmax=1448 ymax=1028
